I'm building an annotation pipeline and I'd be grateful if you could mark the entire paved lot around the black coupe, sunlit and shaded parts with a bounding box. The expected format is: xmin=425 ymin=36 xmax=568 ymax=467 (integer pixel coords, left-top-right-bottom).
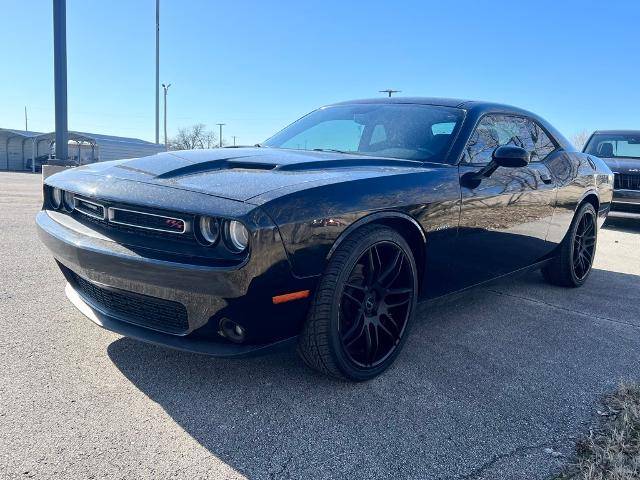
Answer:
xmin=0 ymin=172 xmax=640 ymax=479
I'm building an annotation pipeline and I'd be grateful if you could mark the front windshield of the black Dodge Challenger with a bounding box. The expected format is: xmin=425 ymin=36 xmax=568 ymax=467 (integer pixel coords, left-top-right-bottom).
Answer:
xmin=262 ymin=104 xmax=464 ymax=162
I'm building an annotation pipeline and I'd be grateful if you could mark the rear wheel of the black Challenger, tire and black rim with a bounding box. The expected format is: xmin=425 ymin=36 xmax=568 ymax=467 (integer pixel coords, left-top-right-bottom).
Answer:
xmin=542 ymin=203 xmax=598 ymax=288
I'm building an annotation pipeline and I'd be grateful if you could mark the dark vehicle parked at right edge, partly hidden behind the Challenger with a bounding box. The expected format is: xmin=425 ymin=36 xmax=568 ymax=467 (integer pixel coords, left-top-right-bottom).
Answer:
xmin=584 ymin=130 xmax=640 ymax=219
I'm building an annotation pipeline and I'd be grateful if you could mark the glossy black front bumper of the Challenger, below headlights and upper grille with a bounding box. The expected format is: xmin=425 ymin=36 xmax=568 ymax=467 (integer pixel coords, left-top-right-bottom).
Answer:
xmin=36 ymin=210 xmax=317 ymax=357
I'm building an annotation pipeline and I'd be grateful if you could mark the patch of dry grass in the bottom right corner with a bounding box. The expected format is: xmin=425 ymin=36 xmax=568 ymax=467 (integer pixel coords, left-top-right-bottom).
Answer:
xmin=556 ymin=384 xmax=640 ymax=480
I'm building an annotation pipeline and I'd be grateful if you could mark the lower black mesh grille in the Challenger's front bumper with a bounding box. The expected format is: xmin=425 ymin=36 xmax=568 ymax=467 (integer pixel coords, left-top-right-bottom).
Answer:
xmin=71 ymin=272 xmax=189 ymax=334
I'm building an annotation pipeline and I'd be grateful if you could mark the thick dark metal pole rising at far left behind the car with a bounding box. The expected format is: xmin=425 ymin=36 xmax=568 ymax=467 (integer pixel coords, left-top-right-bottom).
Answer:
xmin=53 ymin=0 xmax=69 ymax=164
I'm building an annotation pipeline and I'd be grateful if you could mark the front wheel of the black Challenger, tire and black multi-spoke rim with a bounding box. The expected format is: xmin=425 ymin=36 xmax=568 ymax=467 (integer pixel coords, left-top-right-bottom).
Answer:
xmin=298 ymin=225 xmax=418 ymax=381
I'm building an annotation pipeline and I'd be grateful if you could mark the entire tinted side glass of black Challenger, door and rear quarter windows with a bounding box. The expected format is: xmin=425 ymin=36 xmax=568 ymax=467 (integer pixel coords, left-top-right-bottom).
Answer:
xmin=465 ymin=115 xmax=556 ymax=164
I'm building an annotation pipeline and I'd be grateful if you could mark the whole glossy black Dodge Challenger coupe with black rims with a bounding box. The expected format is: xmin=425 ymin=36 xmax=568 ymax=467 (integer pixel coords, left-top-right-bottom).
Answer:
xmin=37 ymin=98 xmax=613 ymax=381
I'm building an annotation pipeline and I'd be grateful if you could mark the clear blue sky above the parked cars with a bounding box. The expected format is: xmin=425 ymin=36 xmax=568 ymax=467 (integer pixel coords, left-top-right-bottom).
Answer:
xmin=0 ymin=0 xmax=640 ymax=144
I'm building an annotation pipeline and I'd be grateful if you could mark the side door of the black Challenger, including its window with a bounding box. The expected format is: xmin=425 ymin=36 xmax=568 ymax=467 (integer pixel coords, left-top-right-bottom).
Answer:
xmin=454 ymin=114 xmax=557 ymax=288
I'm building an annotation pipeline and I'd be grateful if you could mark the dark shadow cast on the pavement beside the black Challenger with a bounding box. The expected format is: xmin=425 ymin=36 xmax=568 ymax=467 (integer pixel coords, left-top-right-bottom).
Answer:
xmin=108 ymin=270 xmax=640 ymax=479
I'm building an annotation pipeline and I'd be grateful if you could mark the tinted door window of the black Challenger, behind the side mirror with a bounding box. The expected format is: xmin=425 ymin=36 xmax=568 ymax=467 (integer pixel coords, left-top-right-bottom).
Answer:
xmin=465 ymin=115 xmax=535 ymax=164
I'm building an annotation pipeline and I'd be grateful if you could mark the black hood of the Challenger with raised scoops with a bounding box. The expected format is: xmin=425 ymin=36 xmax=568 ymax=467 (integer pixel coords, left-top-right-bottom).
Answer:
xmin=78 ymin=147 xmax=430 ymax=201
